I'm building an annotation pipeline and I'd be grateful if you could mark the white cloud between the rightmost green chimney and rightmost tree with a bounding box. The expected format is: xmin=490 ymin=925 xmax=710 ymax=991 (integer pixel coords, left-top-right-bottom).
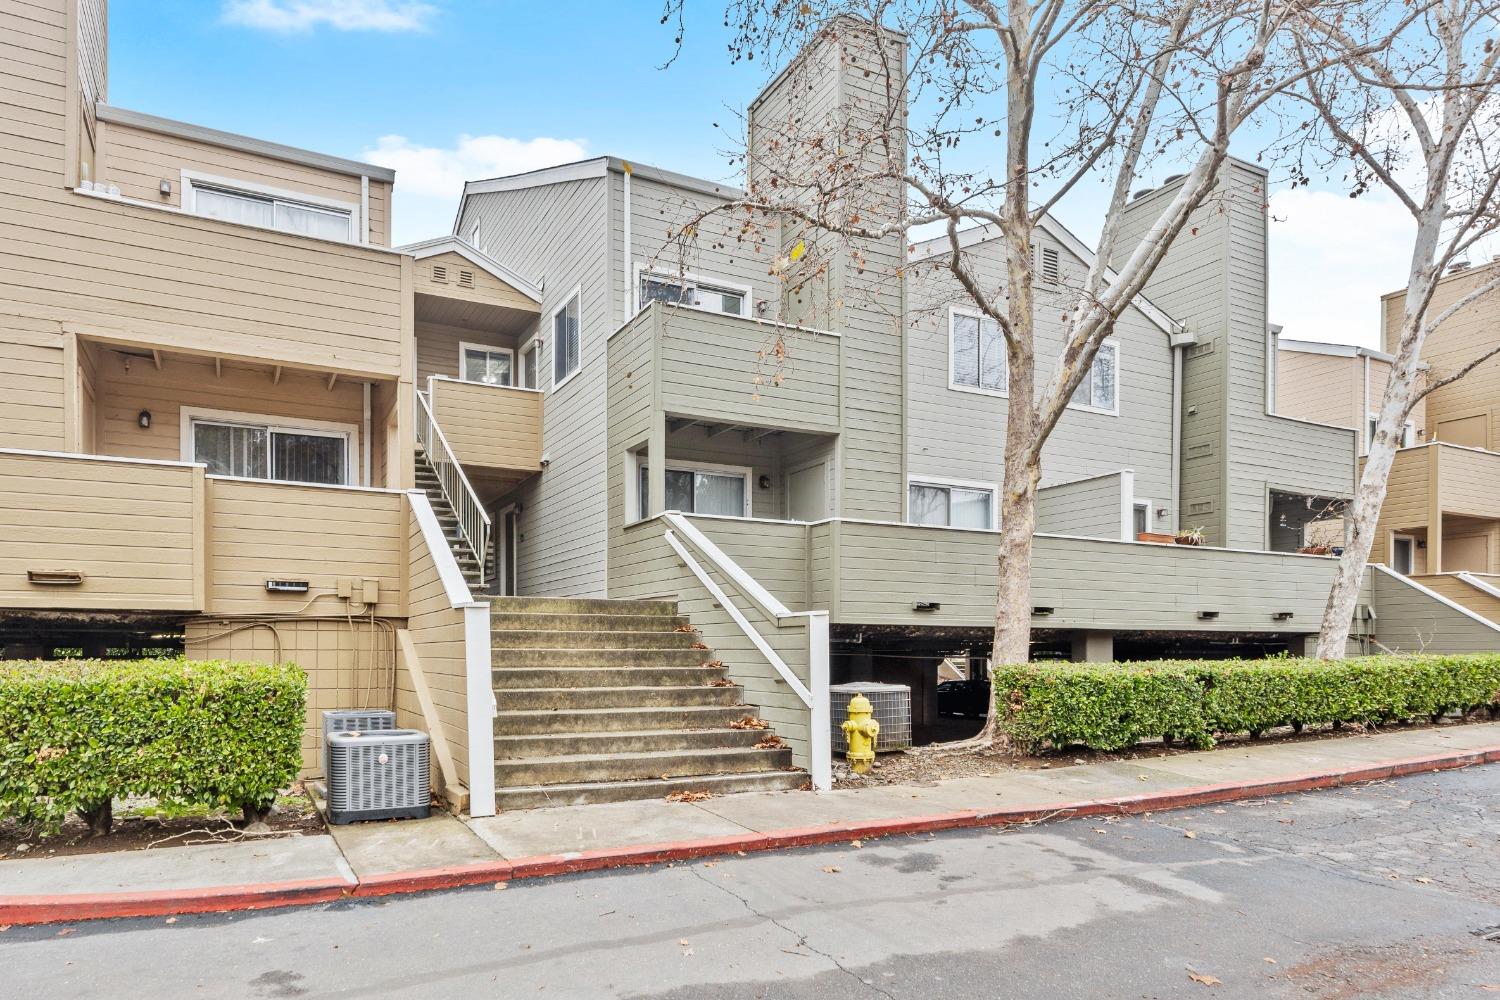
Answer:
xmin=1269 ymin=187 xmax=1416 ymax=348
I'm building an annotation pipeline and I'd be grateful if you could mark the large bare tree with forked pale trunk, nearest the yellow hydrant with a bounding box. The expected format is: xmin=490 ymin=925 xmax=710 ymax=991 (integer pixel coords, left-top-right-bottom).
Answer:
xmin=663 ymin=0 xmax=1392 ymax=741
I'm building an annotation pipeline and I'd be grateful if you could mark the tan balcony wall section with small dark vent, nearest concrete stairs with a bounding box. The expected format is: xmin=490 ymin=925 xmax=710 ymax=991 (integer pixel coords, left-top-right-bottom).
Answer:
xmin=209 ymin=478 xmax=405 ymax=616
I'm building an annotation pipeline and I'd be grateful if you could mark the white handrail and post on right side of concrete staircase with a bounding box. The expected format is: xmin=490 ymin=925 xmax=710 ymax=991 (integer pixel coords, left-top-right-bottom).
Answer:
xmin=663 ymin=511 xmax=833 ymax=792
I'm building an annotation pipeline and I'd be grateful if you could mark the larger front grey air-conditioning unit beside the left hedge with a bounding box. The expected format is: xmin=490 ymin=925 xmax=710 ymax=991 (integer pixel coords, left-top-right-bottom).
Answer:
xmin=327 ymin=729 xmax=432 ymax=825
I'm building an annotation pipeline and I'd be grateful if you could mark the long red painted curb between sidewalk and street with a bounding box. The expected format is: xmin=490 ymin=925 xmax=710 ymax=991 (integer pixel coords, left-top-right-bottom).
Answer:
xmin=0 ymin=747 xmax=1500 ymax=927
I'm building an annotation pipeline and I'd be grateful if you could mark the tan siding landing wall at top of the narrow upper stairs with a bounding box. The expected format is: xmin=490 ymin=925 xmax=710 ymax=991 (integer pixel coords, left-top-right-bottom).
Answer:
xmin=432 ymin=381 xmax=542 ymax=471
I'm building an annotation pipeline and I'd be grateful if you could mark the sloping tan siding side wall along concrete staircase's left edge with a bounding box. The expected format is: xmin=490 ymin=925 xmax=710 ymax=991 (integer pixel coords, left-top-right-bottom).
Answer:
xmin=396 ymin=511 xmax=470 ymax=784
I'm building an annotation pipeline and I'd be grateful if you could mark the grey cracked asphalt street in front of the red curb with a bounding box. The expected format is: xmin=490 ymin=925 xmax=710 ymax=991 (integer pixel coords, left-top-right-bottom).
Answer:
xmin=0 ymin=765 xmax=1500 ymax=1000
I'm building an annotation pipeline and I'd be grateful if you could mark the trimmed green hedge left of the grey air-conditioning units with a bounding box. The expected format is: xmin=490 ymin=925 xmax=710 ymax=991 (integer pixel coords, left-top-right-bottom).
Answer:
xmin=0 ymin=660 xmax=308 ymax=829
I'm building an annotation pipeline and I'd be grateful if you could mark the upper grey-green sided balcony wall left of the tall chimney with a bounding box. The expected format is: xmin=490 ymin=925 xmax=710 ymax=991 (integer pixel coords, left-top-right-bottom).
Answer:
xmin=609 ymin=303 xmax=843 ymax=433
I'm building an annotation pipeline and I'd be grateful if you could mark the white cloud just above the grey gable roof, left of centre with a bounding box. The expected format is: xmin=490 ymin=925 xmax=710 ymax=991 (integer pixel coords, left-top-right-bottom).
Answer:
xmin=362 ymin=135 xmax=588 ymax=244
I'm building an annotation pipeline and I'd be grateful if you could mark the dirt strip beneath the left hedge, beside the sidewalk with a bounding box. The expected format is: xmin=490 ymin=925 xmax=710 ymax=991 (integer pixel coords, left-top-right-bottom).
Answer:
xmin=0 ymin=783 xmax=324 ymax=861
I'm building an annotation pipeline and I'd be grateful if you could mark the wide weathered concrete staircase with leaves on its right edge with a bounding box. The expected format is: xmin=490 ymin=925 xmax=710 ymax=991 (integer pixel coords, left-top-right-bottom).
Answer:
xmin=491 ymin=597 xmax=807 ymax=810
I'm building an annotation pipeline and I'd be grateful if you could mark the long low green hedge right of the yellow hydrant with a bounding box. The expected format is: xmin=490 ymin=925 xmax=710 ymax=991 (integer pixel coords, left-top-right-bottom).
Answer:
xmin=993 ymin=654 xmax=1500 ymax=751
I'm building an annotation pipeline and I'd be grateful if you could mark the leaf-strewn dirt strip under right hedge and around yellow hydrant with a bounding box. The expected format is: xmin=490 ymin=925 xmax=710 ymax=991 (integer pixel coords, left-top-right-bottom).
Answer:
xmin=834 ymin=714 xmax=1490 ymax=789
